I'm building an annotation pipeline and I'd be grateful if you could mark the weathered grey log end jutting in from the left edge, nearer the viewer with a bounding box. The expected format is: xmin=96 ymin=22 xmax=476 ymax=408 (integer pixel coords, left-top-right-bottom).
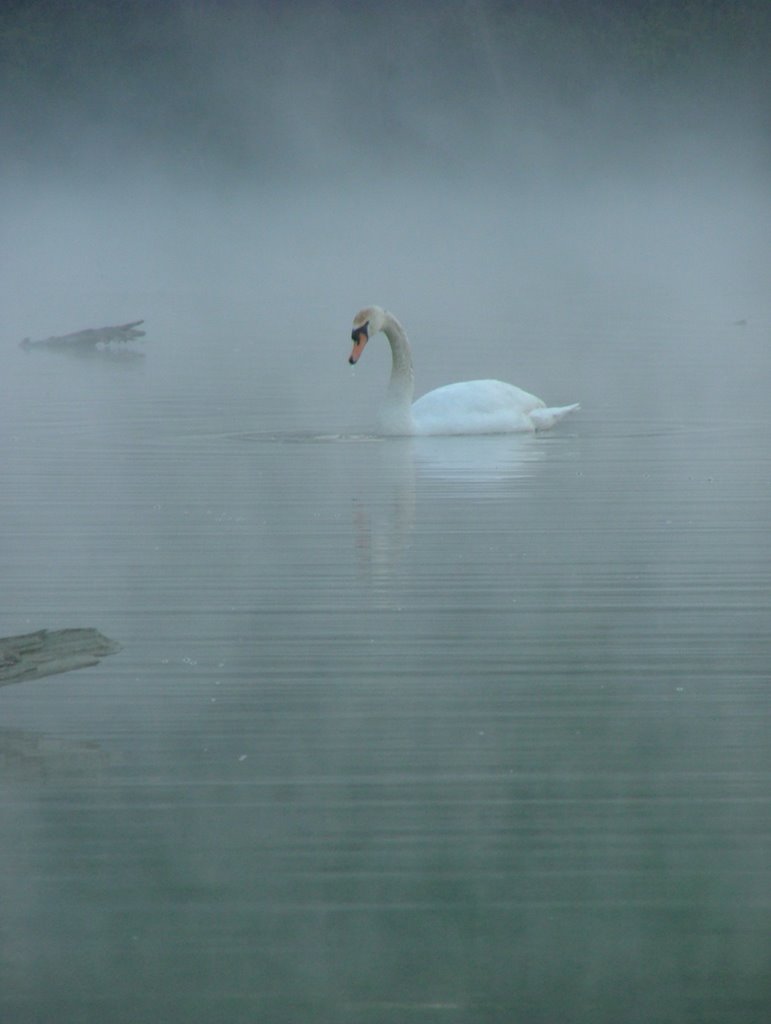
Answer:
xmin=0 ymin=629 xmax=122 ymax=686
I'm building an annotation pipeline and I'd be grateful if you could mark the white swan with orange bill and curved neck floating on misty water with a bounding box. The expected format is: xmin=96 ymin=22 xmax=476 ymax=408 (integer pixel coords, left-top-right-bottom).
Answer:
xmin=348 ymin=306 xmax=579 ymax=434
